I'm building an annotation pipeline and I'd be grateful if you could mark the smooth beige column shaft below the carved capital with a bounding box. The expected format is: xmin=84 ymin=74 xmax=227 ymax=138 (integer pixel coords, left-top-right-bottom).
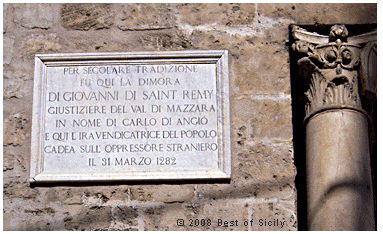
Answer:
xmin=306 ymin=109 xmax=375 ymax=231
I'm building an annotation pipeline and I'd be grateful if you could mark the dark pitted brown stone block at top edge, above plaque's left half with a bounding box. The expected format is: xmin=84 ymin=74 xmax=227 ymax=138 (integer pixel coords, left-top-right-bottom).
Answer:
xmin=60 ymin=3 xmax=114 ymax=31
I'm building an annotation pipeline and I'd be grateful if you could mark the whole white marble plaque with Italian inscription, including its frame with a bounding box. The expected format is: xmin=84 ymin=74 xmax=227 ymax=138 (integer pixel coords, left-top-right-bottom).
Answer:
xmin=30 ymin=51 xmax=231 ymax=183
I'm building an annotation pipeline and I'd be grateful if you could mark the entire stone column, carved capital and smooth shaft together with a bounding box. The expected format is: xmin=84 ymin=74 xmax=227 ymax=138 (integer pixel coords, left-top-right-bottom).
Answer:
xmin=292 ymin=25 xmax=376 ymax=231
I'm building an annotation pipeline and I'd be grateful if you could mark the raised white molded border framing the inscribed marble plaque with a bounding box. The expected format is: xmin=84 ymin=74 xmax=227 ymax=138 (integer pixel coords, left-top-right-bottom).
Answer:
xmin=29 ymin=50 xmax=231 ymax=183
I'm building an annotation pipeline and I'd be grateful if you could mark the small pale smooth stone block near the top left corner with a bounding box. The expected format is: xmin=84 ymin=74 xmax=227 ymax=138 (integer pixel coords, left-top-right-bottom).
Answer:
xmin=14 ymin=4 xmax=54 ymax=29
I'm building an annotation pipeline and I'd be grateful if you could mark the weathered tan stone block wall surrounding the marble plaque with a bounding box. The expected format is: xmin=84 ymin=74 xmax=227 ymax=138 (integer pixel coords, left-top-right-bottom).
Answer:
xmin=3 ymin=4 xmax=377 ymax=230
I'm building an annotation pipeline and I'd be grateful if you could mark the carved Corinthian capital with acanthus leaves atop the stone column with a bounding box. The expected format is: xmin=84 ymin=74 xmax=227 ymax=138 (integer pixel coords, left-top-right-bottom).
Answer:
xmin=292 ymin=25 xmax=376 ymax=117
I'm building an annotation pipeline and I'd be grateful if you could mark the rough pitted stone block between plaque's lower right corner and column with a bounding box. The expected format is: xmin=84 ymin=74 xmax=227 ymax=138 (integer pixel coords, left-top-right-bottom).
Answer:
xmin=233 ymin=143 xmax=296 ymax=200
